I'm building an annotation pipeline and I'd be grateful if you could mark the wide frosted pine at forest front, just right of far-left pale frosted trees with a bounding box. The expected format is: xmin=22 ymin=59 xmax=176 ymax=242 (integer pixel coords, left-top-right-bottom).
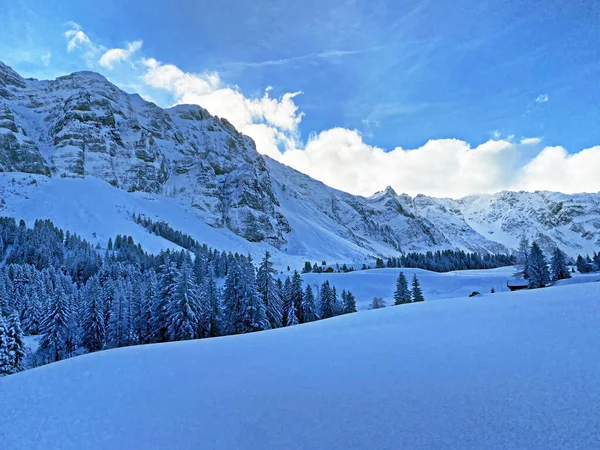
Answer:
xmin=38 ymin=289 xmax=71 ymax=362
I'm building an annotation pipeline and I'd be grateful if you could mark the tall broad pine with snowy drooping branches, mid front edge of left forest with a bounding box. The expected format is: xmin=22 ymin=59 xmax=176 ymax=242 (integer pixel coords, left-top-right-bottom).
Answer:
xmin=167 ymin=262 xmax=205 ymax=341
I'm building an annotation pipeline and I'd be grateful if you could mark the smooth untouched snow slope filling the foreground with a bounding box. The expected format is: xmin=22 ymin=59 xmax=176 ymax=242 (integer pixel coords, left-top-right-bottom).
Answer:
xmin=0 ymin=283 xmax=600 ymax=450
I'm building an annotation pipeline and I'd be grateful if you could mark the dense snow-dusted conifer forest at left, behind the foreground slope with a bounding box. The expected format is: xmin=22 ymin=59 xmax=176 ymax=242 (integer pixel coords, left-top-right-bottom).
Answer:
xmin=0 ymin=218 xmax=356 ymax=374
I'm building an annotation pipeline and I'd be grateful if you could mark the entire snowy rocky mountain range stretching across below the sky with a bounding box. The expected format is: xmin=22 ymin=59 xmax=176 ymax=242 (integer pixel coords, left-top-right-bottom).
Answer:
xmin=0 ymin=63 xmax=600 ymax=258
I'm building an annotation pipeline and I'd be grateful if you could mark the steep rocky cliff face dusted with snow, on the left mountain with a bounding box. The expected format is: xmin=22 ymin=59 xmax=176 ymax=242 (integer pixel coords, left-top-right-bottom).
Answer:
xmin=0 ymin=61 xmax=289 ymax=246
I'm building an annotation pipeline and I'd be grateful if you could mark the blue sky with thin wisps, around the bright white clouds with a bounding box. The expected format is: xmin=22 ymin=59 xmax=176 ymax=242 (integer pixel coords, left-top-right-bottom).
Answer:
xmin=0 ymin=0 xmax=600 ymax=194
